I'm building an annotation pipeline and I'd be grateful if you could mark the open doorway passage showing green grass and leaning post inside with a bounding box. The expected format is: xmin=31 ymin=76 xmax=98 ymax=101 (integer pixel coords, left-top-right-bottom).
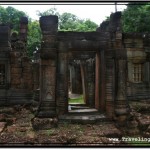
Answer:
xmin=68 ymin=51 xmax=99 ymax=112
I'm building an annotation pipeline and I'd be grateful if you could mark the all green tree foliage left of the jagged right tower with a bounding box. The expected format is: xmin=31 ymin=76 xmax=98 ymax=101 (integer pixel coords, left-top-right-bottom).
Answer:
xmin=0 ymin=6 xmax=98 ymax=58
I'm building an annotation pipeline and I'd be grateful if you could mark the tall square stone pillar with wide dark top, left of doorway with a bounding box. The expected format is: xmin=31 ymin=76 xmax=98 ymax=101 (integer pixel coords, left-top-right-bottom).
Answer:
xmin=37 ymin=15 xmax=58 ymax=117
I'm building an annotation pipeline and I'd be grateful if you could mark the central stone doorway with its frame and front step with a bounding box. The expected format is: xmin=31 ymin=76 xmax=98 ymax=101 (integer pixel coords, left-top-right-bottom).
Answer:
xmin=57 ymin=49 xmax=106 ymax=123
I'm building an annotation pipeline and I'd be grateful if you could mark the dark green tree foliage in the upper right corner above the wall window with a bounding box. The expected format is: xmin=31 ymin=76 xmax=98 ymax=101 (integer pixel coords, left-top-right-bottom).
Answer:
xmin=122 ymin=2 xmax=150 ymax=32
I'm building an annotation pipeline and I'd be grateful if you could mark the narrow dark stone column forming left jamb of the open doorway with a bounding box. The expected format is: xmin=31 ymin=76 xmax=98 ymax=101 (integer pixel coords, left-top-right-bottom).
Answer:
xmin=56 ymin=42 xmax=69 ymax=115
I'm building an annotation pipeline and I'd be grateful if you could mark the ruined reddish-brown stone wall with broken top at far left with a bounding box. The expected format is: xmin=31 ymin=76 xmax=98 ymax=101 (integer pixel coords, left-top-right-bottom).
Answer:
xmin=0 ymin=17 xmax=33 ymax=105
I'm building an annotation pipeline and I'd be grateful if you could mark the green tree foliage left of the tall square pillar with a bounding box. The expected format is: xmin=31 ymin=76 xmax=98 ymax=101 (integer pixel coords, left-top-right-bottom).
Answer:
xmin=0 ymin=6 xmax=37 ymax=57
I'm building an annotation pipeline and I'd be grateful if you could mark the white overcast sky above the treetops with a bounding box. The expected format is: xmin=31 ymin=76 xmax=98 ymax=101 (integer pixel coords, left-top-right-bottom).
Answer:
xmin=0 ymin=3 xmax=126 ymax=25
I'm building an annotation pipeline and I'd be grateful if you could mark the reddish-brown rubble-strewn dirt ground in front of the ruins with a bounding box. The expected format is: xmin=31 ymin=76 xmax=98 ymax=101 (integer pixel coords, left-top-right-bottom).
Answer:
xmin=0 ymin=106 xmax=149 ymax=146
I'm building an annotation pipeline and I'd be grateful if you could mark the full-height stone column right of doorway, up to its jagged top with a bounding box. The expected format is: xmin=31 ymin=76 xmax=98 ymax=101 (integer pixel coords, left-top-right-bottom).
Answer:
xmin=106 ymin=12 xmax=129 ymax=122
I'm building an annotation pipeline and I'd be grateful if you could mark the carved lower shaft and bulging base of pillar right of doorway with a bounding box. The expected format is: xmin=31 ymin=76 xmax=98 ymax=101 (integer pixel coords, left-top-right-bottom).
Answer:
xmin=115 ymin=59 xmax=129 ymax=125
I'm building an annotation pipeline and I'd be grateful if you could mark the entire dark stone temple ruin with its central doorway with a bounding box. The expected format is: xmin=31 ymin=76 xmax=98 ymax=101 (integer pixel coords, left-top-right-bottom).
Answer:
xmin=0 ymin=12 xmax=150 ymax=127
